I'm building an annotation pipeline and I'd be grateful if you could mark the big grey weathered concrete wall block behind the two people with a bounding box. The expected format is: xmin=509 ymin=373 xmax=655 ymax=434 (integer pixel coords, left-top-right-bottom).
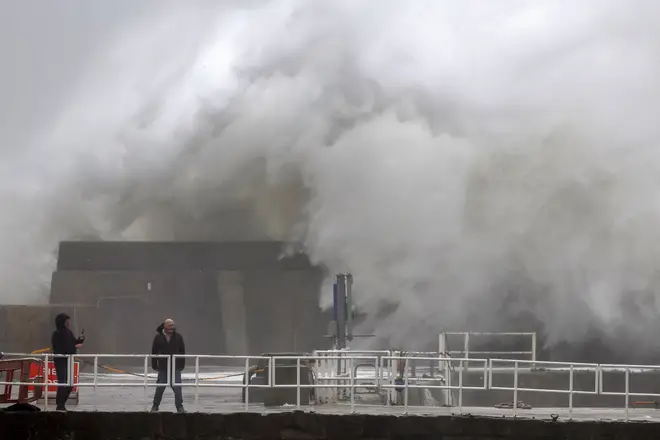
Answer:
xmin=51 ymin=242 xmax=328 ymax=355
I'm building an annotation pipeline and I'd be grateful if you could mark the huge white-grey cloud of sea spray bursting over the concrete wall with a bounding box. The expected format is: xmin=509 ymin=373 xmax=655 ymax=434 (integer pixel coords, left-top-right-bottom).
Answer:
xmin=0 ymin=0 xmax=660 ymax=356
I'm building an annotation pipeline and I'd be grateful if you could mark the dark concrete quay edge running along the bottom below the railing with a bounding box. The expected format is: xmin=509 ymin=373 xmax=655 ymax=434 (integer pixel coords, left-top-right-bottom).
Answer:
xmin=0 ymin=412 xmax=660 ymax=440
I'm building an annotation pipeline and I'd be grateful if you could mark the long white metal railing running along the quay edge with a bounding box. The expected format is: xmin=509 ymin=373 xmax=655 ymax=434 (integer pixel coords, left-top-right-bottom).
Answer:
xmin=0 ymin=350 xmax=660 ymax=420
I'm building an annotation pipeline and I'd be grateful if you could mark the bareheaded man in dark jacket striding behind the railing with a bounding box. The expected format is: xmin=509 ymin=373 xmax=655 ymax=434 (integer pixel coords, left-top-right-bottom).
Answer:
xmin=151 ymin=319 xmax=186 ymax=413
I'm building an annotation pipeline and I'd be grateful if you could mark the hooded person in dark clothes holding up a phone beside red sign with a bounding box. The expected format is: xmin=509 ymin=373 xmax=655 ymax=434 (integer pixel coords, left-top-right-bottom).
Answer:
xmin=51 ymin=313 xmax=85 ymax=411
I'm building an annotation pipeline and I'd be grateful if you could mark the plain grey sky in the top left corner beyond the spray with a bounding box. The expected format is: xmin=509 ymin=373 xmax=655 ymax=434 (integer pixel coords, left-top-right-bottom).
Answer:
xmin=0 ymin=0 xmax=152 ymax=150
